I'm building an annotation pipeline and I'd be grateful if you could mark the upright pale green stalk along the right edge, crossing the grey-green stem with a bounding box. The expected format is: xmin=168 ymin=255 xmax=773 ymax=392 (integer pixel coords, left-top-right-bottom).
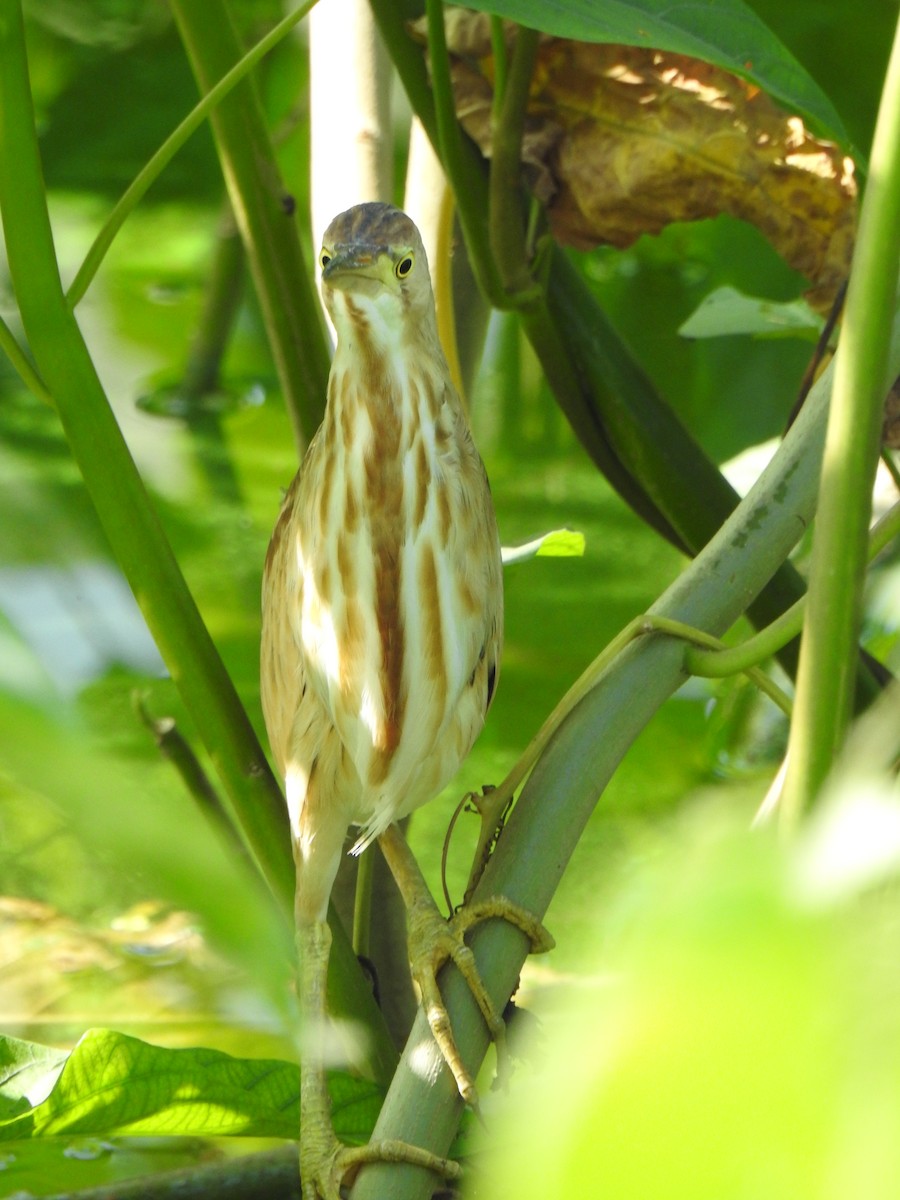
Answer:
xmin=782 ymin=20 xmax=900 ymax=824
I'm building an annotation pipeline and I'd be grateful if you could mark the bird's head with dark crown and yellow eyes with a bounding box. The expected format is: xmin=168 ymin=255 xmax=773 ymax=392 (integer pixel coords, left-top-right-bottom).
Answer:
xmin=319 ymin=203 xmax=434 ymax=338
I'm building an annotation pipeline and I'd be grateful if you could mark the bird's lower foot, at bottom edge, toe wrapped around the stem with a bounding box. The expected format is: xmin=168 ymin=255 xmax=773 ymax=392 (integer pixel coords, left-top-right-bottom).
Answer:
xmin=300 ymin=1121 xmax=462 ymax=1200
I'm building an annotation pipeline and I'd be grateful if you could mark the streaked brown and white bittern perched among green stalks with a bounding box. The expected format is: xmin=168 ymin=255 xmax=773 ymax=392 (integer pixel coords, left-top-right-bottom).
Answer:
xmin=256 ymin=203 xmax=542 ymax=1200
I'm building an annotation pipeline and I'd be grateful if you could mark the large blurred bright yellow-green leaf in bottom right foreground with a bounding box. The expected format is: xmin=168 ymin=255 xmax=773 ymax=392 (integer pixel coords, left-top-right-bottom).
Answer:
xmin=485 ymin=782 xmax=900 ymax=1200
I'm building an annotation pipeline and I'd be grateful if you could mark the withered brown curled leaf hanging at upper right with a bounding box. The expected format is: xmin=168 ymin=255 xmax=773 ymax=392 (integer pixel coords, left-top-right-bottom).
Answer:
xmin=422 ymin=11 xmax=857 ymax=308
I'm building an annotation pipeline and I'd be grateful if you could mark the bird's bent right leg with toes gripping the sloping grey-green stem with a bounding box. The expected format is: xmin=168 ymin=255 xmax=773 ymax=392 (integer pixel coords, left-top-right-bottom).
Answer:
xmin=378 ymin=824 xmax=554 ymax=1111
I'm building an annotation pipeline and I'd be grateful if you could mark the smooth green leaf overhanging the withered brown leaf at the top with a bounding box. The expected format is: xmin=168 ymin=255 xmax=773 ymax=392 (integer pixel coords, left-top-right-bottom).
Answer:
xmin=469 ymin=0 xmax=848 ymax=145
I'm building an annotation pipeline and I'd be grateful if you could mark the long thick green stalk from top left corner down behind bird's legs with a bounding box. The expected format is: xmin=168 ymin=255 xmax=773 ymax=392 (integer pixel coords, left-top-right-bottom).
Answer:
xmin=0 ymin=0 xmax=396 ymax=1079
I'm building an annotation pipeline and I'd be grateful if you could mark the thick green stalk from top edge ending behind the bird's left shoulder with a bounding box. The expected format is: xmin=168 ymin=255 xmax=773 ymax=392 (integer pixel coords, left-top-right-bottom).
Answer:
xmin=170 ymin=0 xmax=330 ymax=451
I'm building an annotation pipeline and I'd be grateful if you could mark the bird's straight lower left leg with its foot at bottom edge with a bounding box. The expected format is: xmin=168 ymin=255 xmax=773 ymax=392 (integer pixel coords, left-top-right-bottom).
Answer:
xmin=296 ymin=920 xmax=461 ymax=1200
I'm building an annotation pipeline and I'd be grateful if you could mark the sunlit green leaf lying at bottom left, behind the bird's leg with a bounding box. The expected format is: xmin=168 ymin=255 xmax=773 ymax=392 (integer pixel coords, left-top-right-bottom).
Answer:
xmin=0 ymin=1030 xmax=383 ymax=1144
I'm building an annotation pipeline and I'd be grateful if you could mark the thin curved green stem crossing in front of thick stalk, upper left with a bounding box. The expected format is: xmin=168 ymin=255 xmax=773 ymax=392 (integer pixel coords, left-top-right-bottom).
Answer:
xmin=66 ymin=0 xmax=316 ymax=308
